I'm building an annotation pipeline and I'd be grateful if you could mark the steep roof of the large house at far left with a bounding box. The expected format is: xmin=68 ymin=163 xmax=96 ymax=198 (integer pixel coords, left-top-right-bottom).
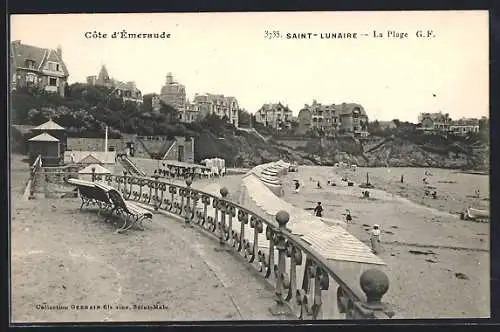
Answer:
xmin=10 ymin=41 xmax=69 ymax=76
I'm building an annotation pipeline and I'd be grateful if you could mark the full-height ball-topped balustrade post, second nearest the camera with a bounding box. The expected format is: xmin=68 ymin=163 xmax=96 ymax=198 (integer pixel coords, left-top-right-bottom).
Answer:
xmin=270 ymin=210 xmax=292 ymax=316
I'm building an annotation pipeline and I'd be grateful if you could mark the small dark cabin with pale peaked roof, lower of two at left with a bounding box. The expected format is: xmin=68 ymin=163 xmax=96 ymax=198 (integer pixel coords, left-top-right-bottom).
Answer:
xmin=28 ymin=133 xmax=62 ymax=166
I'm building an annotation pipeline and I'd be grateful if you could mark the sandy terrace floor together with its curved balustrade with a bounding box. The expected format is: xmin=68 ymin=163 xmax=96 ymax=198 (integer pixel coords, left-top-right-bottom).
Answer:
xmin=12 ymin=155 xmax=394 ymax=321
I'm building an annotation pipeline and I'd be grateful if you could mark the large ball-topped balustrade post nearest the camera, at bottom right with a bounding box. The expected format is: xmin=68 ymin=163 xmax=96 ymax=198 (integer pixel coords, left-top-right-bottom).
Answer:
xmin=356 ymin=269 xmax=394 ymax=319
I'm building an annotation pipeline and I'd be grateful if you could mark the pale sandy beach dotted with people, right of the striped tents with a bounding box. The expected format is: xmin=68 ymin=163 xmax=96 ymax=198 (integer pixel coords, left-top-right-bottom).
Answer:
xmin=283 ymin=166 xmax=490 ymax=318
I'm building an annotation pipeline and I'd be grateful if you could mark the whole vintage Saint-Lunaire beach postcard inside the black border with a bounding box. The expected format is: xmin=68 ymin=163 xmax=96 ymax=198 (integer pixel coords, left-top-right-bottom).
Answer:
xmin=9 ymin=11 xmax=490 ymax=324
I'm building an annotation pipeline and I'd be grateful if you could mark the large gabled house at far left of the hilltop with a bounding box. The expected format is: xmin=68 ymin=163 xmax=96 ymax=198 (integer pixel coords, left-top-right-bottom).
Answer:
xmin=10 ymin=40 xmax=69 ymax=97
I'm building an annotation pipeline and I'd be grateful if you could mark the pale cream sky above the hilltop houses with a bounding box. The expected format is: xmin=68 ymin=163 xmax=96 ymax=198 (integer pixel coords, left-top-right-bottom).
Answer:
xmin=10 ymin=11 xmax=489 ymax=122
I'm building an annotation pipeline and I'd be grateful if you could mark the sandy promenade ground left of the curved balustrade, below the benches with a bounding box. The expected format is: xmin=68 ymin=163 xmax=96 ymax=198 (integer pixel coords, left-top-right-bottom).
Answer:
xmin=11 ymin=157 xmax=290 ymax=322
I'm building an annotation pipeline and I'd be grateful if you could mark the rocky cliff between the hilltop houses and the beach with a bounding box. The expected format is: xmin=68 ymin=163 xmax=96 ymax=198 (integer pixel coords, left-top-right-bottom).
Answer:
xmin=211 ymin=133 xmax=489 ymax=170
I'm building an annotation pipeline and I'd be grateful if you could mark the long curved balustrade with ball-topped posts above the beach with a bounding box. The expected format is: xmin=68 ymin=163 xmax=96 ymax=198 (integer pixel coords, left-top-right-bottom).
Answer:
xmin=88 ymin=173 xmax=394 ymax=320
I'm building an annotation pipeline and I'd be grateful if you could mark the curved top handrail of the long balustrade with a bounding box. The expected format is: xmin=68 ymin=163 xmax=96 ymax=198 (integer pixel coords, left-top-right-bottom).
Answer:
xmin=96 ymin=174 xmax=391 ymax=317
